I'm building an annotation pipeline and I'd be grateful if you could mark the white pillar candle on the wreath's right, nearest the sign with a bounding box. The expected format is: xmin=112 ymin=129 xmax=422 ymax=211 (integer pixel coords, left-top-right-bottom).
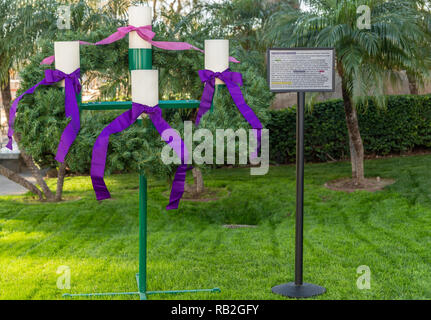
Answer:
xmin=205 ymin=40 xmax=229 ymax=84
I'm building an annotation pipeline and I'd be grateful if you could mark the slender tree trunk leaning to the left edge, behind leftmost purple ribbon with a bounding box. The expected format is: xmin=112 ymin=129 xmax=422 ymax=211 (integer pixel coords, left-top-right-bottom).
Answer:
xmin=1 ymin=70 xmax=55 ymax=201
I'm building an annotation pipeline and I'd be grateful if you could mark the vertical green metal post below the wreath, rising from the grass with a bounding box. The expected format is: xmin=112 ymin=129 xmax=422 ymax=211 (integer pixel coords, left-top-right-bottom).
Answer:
xmin=138 ymin=173 xmax=147 ymax=300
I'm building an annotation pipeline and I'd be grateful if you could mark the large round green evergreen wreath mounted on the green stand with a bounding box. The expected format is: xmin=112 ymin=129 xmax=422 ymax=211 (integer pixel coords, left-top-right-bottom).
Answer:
xmin=16 ymin=1 xmax=272 ymax=198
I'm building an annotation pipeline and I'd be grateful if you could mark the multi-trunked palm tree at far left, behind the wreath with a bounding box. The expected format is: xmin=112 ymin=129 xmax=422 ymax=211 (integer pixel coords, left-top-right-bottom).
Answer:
xmin=0 ymin=0 xmax=125 ymax=201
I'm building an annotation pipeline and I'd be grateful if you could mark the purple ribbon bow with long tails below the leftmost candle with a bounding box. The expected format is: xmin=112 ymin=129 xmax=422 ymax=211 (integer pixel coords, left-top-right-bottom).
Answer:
xmin=6 ymin=68 xmax=81 ymax=162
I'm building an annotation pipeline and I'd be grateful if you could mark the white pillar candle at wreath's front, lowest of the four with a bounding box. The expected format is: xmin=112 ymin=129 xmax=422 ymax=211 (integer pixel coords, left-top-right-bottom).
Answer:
xmin=131 ymin=70 xmax=159 ymax=107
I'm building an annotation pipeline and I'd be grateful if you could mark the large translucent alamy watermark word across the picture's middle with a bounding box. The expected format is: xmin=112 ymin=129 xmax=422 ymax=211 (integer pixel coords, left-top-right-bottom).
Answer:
xmin=161 ymin=121 xmax=269 ymax=175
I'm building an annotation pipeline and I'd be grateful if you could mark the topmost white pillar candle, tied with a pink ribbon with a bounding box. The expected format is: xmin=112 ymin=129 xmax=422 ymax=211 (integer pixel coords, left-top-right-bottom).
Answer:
xmin=129 ymin=6 xmax=152 ymax=49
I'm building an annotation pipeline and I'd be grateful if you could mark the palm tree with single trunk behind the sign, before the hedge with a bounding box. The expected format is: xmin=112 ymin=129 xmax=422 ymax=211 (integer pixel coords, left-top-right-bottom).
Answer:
xmin=268 ymin=0 xmax=430 ymax=187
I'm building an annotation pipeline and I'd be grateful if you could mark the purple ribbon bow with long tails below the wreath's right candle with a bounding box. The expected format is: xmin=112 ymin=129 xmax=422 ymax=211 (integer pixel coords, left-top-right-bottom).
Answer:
xmin=195 ymin=68 xmax=262 ymax=158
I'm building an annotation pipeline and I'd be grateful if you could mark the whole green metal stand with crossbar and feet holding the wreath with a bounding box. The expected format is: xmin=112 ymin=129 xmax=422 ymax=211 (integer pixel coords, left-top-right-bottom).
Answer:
xmin=63 ymin=49 xmax=221 ymax=300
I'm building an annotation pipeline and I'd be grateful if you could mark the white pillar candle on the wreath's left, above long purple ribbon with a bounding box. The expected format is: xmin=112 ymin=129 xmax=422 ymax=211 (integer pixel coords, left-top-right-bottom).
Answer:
xmin=54 ymin=41 xmax=80 ymax=87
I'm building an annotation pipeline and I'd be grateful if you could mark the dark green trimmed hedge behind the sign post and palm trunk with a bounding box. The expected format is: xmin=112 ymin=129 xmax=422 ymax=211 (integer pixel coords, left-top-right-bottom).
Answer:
xmin=267 ymin=95 xmax=431 ymax=164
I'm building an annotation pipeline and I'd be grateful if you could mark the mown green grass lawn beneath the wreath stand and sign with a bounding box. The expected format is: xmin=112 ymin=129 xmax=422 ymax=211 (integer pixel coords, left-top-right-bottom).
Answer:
xmin=0 ymin=155 xmax=431 ymax=299
